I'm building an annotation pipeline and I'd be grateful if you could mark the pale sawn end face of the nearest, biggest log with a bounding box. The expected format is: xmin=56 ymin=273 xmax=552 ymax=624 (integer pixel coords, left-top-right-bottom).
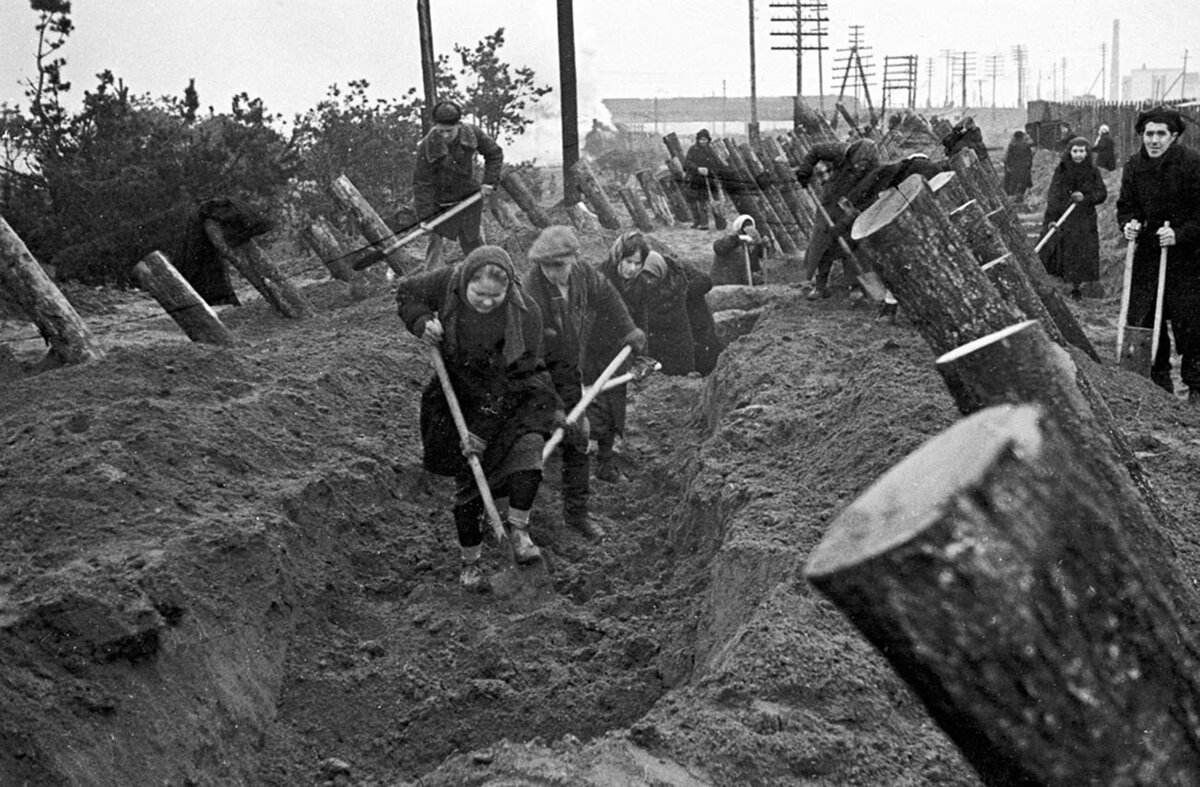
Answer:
xmin=804 ymin=404 xmax=1042 ymax=587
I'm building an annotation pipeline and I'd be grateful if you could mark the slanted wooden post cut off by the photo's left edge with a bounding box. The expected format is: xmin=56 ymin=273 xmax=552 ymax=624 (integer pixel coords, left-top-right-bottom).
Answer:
xmin=0 ymin=216 xmax=104 ymax=364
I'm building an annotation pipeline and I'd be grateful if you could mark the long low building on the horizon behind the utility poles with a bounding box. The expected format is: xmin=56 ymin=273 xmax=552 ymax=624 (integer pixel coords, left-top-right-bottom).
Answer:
xmin=601 ymin=96 xmax=868 ymax=140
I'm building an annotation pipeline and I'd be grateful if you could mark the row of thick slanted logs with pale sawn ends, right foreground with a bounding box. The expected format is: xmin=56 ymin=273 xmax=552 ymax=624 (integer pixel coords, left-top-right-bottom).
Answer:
xmin=805 ymin=165 xmax=1200 ymax=785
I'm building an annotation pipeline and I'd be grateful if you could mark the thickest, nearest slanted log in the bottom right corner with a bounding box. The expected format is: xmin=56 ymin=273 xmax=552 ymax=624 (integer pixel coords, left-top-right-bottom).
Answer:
xmin=805 ymin=405 xmax=1200 ymax=786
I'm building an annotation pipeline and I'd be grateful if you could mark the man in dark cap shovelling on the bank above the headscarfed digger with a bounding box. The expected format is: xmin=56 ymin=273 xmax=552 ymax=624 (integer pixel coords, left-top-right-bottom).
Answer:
xmin=413 ymin=101 xmax=504 ymax=270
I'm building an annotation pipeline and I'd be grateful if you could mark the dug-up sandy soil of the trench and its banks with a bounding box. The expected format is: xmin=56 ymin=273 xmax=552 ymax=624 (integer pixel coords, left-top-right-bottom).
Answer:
xmin=0 ymin=193 xmax=1200 ymax=787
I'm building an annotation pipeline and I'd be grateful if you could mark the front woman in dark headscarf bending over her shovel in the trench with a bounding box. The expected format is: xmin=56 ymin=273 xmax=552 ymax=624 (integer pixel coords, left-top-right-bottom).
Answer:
xmin=396 ymin=246 xmax=564 ymax=590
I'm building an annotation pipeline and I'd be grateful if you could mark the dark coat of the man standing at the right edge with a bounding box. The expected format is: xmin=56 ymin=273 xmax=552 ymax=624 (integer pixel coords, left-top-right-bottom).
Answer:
xmin=1117 ymin=142 xmax=1200 ymax=298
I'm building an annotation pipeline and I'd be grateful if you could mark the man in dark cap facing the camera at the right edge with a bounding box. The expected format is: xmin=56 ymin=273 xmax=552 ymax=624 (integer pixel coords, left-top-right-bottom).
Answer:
xmin=1117 ymin=107 xmax=1200 ymax=404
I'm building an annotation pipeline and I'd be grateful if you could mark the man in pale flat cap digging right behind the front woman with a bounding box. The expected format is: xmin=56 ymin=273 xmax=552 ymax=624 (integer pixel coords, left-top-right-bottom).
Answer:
xmin=526 ymin=224 xmax=646 ymax=541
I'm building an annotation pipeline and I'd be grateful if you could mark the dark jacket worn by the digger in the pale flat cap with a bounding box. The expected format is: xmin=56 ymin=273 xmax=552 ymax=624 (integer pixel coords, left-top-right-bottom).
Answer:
xmin=526 ymin=262 xmax=636 ymax=409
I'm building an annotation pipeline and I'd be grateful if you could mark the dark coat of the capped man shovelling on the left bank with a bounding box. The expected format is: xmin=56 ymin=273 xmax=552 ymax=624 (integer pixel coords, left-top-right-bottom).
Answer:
xmin=413 ymin=122 xmax=504 ymax=239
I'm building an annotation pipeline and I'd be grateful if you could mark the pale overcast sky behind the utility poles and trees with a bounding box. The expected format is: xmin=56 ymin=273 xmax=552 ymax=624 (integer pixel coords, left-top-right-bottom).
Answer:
xmin=0 ymin=0 xmax=1200 ymax=160
